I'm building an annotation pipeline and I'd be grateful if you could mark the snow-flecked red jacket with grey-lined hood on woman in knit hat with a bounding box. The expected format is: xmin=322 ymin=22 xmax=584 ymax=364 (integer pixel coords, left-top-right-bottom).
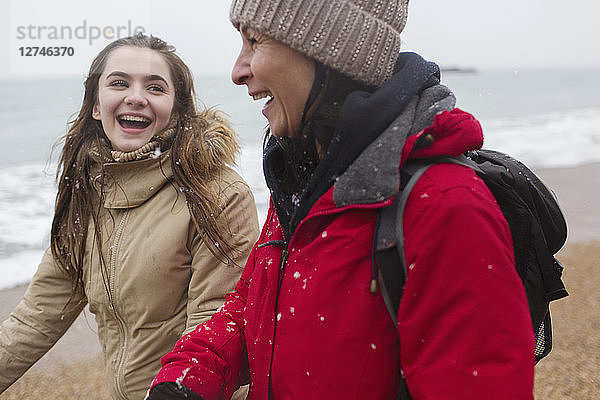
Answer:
xmin=153 ymin=54 xmax=534 ymax=400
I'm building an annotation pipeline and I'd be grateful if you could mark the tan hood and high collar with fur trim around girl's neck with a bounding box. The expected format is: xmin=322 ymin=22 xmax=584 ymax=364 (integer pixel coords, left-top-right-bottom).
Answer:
xmin=90 ymin=109 xmax=239 ymax=208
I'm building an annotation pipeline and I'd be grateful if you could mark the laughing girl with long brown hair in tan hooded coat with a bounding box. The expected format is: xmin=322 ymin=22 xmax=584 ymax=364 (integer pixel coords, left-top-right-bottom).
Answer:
xmin=0 ymin=35 xmax=258 ymax=399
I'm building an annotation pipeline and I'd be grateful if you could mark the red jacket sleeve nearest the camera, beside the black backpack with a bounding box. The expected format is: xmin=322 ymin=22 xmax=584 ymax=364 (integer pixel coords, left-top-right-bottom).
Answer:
xmin=398 ymin=165 xmax=535 ymax=400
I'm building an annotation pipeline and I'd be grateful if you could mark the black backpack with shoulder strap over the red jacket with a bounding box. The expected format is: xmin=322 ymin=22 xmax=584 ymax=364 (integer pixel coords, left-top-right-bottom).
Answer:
xmin=373 ymin=150 xmax=568 ymax=399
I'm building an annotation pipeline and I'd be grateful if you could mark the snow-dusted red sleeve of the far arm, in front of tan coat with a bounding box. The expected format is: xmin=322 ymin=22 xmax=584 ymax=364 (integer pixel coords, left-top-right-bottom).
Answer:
xmin=151 ymin=245 xmax=254 ymax=400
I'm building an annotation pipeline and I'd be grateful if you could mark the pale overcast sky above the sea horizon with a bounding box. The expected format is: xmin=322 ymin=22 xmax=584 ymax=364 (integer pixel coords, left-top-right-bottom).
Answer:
xmin=0 ymin=0 xmax=600 ymax=79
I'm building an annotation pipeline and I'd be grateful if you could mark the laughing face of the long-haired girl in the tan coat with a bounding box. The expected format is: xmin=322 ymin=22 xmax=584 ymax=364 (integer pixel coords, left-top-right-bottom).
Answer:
xmin=92 ymin=46 xmax=175 ymax=151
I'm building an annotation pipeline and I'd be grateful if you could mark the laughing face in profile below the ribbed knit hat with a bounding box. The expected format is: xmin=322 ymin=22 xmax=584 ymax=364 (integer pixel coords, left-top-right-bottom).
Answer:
xmin=231 ymin=29 xmax=315 ymax=137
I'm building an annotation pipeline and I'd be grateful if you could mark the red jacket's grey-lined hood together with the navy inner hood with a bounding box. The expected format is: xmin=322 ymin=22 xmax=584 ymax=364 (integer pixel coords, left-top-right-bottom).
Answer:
xmin=264 ymin=53 xmax=483 ymax=241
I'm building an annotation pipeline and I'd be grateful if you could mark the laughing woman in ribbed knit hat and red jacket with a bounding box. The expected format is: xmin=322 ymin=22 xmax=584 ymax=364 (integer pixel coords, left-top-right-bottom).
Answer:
xmin=149 ymin=0 xmax=534 ymax=400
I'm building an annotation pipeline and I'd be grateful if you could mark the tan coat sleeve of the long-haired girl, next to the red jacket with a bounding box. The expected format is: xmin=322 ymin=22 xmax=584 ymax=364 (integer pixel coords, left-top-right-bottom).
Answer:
xmin=183 ymin=171 xmax=259 ymax=334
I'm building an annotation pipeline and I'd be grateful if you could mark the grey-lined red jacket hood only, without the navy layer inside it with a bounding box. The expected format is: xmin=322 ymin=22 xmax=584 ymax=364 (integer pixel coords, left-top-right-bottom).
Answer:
xmin=333 ymin=101 xmax=483 ymax=207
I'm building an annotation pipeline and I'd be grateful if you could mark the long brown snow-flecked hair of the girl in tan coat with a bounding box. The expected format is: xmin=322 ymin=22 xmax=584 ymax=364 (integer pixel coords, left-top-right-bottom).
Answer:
xmin=50 ymin=34 xmax=238 ymax=301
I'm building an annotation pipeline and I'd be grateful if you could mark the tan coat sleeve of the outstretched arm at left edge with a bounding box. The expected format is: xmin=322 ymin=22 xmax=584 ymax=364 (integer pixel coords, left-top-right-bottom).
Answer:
xmin=0 ymin=250 xmax=87 ymax=393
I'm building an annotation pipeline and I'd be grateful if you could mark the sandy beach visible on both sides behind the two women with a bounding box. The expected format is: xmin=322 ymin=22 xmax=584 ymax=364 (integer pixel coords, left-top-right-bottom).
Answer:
xmin=0 ymin=164 xmax=600 ymax=400
